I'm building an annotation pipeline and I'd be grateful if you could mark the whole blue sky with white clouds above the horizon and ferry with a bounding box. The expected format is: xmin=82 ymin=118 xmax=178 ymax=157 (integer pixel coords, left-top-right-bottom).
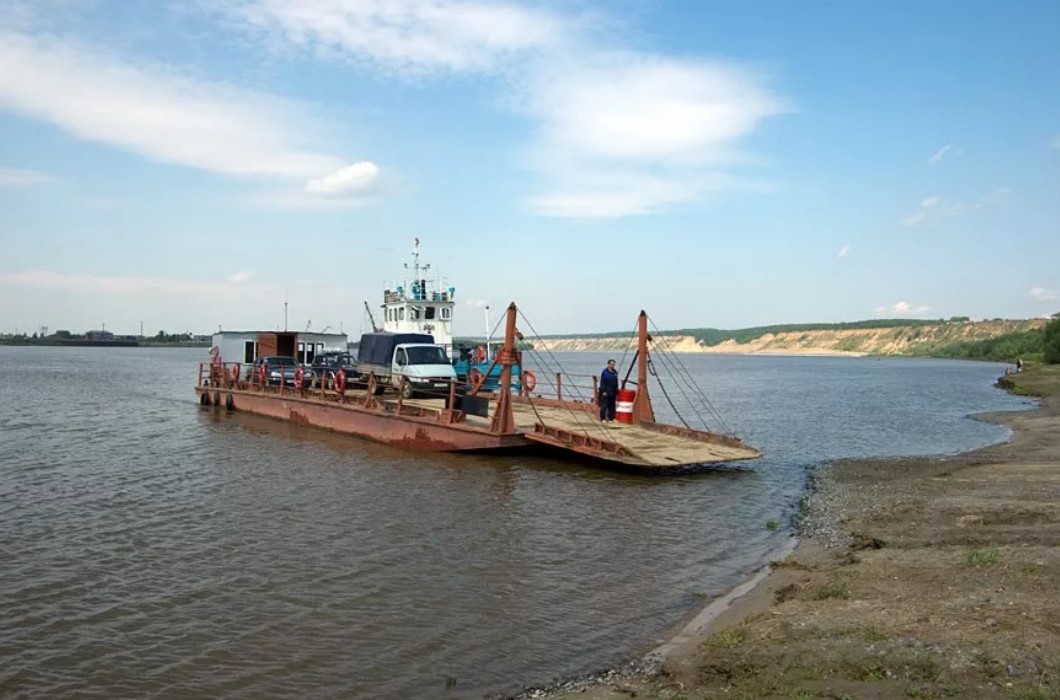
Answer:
xmin=0 ymin=0 xmax=1060 ymax=334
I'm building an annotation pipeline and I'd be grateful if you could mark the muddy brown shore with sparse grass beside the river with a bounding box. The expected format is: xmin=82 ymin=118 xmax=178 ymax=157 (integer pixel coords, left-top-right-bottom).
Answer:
xmin=538 ymin=367 xmax=1060 ymax=700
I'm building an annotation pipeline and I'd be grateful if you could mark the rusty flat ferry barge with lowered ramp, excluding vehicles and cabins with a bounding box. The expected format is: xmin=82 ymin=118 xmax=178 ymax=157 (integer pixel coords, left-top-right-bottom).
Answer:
xmin=195 ymin=298 xmax=761 ymax=472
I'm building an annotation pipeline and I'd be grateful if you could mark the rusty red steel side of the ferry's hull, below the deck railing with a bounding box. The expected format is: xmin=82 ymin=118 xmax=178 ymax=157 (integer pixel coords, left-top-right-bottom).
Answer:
xmin=195 ymin=387 xmax=528 ymax=452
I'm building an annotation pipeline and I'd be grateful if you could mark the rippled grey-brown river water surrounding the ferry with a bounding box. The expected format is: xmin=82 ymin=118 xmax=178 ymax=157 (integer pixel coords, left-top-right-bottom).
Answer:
xmin=0 ymin=348 xmax=1032 ymax=698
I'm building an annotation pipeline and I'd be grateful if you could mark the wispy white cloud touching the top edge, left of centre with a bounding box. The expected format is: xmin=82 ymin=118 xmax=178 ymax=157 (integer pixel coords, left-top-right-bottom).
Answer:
xmin=204 ymin=0 xmax=570 ymax=75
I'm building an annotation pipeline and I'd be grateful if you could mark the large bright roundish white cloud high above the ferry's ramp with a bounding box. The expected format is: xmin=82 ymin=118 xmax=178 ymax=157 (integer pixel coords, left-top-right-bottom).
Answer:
xmin=514 ymin=53 xmax=788 ymax=216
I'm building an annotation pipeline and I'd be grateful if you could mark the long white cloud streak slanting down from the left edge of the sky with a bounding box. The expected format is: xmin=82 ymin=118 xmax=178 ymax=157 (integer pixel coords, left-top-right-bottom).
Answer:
xmin=0 ymin=31 xmax=351 ymax=179
